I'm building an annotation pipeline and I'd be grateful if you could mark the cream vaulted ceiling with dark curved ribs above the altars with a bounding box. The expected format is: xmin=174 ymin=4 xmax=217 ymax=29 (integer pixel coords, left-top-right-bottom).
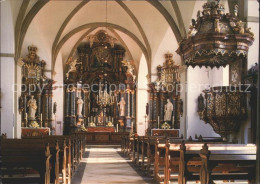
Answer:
xmin=10 ymin=0 xmax=211 ymax=77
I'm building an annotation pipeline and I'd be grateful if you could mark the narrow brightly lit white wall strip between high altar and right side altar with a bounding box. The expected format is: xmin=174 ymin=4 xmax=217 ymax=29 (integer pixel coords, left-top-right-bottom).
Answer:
xmin=136 ymin=55 xmax=148 ymax=136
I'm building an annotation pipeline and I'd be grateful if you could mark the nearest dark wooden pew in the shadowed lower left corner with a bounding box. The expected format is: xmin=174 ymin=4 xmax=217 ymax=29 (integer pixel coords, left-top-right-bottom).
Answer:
xmin=0 ymin=139 xmax=52 ymax=184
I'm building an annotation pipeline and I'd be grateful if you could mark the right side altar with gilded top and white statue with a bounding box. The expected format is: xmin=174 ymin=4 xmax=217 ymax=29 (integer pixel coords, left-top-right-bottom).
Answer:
xmin=146 ymin=52 xmax=183 ymax=132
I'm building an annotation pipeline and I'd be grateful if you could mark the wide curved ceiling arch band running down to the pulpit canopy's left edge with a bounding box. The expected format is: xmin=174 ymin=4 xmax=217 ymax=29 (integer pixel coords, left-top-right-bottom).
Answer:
xmin=146 ymin=0 xmax=182 ymax=42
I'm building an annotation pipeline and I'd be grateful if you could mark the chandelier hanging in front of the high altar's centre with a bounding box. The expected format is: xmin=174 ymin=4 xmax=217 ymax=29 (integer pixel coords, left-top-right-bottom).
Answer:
xmin=97 ymin=84 xmax=115 ymax=107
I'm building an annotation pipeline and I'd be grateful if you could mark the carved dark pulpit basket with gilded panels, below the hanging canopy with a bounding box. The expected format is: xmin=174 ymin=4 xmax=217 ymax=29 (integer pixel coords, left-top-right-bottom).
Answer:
xmin=198 ymin=86 xmax=247 ymax=138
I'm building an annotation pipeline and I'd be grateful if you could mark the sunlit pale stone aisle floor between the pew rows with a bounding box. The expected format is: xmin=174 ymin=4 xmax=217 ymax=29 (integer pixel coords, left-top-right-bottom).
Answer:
xmin=72 ymin=145 xmax=153 ymax=184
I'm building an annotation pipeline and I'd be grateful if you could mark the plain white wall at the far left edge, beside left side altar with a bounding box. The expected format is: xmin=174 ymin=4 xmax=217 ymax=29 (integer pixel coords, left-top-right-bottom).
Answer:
xmin=0 ymin=1 xmax=16 ymax=138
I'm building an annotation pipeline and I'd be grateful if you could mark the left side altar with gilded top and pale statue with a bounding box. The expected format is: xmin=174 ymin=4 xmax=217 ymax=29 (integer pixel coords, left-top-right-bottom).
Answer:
xmin=19 ymin=45 xmax=54 ymax=128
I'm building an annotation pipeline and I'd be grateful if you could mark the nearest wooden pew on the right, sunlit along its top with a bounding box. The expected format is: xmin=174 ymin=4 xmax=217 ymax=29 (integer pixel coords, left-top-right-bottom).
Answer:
xmin=164 ymin=141 xmax=256 ymax=184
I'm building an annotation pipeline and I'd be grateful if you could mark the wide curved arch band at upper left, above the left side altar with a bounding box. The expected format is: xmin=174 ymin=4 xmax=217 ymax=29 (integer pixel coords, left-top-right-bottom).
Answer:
xmin=15 ymin=0 xmax=49 ymax=58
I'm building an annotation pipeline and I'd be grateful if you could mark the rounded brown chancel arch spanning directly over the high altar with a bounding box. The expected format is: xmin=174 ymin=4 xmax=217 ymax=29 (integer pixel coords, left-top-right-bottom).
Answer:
xmin=54 ymin=22 xmax=150 ymax=75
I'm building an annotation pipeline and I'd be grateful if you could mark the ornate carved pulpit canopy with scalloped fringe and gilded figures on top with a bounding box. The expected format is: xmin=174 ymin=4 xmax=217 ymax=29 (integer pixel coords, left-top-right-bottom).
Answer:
xmin=177 ymin=1 xmax=254 ymax=67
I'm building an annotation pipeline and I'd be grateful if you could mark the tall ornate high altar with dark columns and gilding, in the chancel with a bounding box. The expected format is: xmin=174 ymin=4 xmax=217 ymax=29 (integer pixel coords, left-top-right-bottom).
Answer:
xmin=64 ymin=30 xmax=136 ymax=134
